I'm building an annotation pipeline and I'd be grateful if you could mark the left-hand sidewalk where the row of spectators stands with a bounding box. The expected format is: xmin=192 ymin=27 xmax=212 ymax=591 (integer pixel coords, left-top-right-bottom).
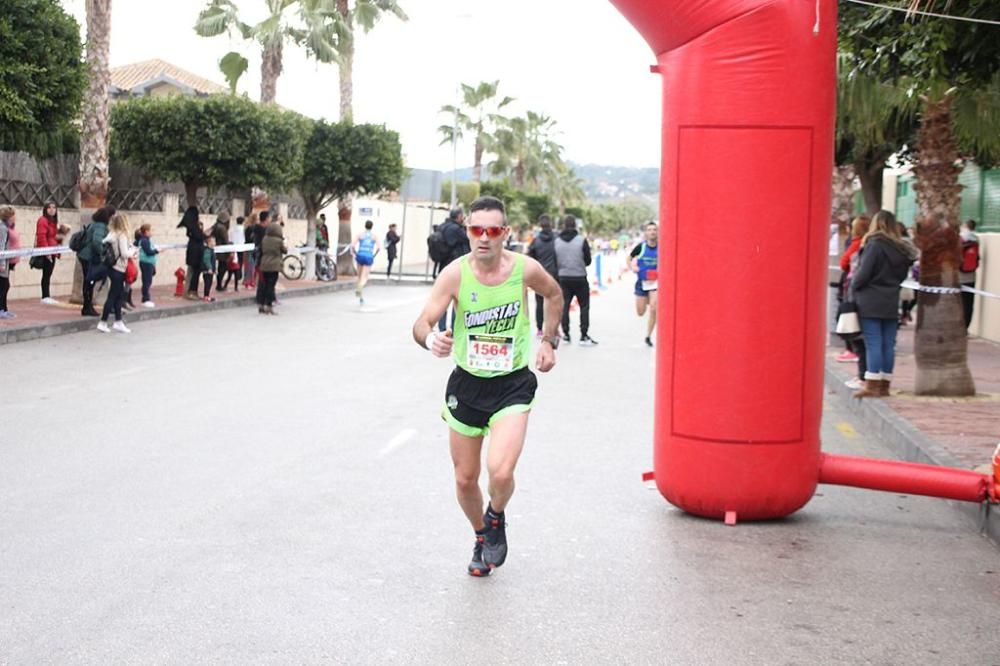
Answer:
xmin=0 ymin=276 xmax=355 ymax=345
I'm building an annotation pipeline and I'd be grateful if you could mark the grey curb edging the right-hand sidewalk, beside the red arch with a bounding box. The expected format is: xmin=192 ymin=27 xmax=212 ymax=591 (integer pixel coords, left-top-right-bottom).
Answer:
xmin=824 ymin=359 xmax=1000 ymax=546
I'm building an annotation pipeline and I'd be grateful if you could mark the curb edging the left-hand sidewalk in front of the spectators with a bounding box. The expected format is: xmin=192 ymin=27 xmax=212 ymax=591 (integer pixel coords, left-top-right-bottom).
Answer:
xmin=0 ymin=280 xmax=354 ymax=345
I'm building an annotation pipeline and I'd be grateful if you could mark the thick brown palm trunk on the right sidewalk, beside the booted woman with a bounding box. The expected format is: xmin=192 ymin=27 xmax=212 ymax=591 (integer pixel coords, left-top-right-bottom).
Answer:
xmin=913 ymin=95 xmax=976 ymax=396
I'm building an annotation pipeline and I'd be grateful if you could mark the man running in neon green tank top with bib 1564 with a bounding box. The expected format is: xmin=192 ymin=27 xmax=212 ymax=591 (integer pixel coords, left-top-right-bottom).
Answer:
xmin=413 ymin=196 xmax=562 ymax=576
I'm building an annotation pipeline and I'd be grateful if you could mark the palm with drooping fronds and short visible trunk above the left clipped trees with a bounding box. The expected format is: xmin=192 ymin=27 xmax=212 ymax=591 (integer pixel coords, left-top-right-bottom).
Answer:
xmin=194 ymin=0 xmax=338 ymax=104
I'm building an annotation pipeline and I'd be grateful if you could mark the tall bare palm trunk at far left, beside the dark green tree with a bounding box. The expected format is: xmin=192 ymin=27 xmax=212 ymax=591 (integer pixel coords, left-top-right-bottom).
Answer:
xmin=79 ymin=0 xmax=111 ymax=209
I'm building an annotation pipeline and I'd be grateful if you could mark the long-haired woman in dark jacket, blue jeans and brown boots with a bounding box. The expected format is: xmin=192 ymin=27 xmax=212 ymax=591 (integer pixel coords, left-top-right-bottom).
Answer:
xmin=851 ymin=210 xmax=917 ymax=398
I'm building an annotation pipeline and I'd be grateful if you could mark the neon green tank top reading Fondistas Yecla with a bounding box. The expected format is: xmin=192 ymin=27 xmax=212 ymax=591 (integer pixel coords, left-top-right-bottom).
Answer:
xmin=452 ymin=254 xmax=531 ymax=377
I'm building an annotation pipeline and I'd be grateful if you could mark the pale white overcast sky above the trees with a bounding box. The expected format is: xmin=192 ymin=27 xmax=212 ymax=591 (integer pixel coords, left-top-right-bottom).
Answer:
xmin=62 ymin=0 xmax=660 ymax=170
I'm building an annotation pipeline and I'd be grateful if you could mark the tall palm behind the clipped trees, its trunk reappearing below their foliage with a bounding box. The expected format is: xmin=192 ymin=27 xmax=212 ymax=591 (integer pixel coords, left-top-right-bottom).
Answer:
xmin=328 ymin=0 xmax=409 ymax=272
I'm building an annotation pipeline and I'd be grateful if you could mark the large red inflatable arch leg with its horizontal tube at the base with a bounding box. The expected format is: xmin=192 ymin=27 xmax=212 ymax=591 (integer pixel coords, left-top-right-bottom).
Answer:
xmin=612 ymin=0 xmax=996 ymax=523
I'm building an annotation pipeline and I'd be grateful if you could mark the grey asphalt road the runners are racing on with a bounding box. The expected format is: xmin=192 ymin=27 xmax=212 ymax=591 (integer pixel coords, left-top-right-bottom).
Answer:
xmin=0 ymin=284 xmax=1000 ymax=664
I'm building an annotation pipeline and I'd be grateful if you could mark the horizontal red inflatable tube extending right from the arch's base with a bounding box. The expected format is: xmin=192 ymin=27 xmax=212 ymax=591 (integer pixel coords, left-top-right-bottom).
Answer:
xmin=819 ymin=453 xmax=993 ymax=502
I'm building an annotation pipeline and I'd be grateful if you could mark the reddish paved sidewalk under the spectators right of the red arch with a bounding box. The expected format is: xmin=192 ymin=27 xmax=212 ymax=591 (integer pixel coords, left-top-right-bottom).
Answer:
xmin=826 ymin=325 xmax=1000 ymax=544
